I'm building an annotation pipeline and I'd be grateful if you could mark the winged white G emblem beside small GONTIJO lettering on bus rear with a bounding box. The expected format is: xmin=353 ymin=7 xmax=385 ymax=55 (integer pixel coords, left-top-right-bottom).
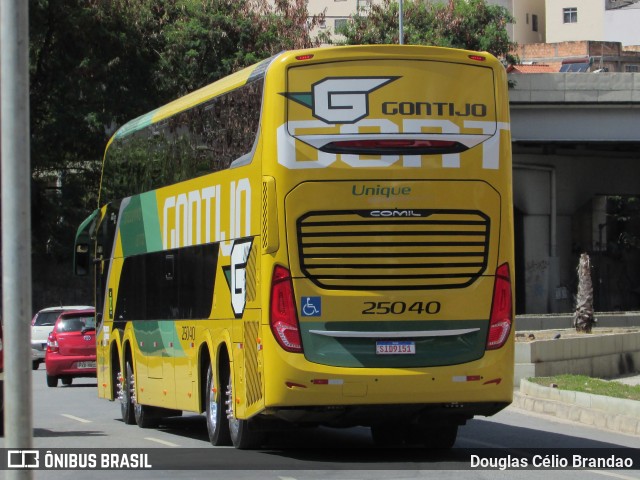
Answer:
xmin=284 ymin=77 xmax=400 ymax=124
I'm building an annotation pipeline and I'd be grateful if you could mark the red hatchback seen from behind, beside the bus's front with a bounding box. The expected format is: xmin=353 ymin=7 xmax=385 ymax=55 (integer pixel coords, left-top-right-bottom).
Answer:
xmin=44 ymin=309 xmax=96 ymax=387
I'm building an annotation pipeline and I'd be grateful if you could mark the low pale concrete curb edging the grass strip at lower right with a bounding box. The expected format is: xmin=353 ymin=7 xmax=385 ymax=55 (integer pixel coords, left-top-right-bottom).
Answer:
xmin=513 ymin=379 xmax=640 ymax=435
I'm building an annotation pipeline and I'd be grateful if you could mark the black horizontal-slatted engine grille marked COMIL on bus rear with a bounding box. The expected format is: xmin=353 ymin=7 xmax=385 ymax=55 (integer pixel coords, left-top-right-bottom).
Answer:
xmin=296 ymin=210 xmax=490 ymax=290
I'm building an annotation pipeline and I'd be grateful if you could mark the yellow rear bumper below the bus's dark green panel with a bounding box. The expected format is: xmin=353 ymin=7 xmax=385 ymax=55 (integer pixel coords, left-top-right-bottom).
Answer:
xmin=265 ymin=348 xmax=513 ymax=425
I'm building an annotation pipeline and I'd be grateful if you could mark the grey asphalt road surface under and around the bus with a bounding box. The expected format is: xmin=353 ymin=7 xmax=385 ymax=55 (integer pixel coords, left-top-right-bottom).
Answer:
xmin=0 ymin=366 xmax=640 ymax=480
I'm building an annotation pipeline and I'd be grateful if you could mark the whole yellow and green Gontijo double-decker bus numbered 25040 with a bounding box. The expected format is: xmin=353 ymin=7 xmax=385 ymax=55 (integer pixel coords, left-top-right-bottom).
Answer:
xmin=75 ymin=45 xmax=514 ymax=448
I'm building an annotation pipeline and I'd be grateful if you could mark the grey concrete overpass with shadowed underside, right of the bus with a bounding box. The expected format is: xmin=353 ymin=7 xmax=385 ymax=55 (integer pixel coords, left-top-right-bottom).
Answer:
xmin=509 ymin=73 xmax=640 ymax=313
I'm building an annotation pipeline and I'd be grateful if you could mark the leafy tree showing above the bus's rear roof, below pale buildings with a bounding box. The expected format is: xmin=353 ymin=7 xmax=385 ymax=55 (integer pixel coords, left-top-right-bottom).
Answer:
xmin=337 ymin=0 xmax=516 ymax=60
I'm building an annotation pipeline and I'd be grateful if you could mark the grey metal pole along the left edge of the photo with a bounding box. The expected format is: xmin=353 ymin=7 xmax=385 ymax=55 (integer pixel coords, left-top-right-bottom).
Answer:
xmin=0 ymin=0 xmax=33 ymax=480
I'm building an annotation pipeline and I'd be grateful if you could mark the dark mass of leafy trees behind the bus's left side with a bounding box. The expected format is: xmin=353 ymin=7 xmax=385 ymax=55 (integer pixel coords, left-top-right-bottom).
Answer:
xmin=29 ymin=0 xmax=319 ymax=304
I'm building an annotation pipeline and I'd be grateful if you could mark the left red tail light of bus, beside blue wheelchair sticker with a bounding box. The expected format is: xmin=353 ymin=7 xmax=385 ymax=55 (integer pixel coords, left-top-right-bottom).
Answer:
xmin=269 ymin=265 xmax=302 ymax=353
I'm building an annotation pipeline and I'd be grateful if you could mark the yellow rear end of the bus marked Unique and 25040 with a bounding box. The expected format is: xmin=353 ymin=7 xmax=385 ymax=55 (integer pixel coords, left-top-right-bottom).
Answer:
xmin=262 ymin=46 xmax=514 ymax=446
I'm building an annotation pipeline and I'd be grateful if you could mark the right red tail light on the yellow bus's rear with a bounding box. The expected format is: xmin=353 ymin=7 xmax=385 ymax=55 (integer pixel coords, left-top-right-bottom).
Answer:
xmin=487 ymin=263 xmax=513 ymax=350
